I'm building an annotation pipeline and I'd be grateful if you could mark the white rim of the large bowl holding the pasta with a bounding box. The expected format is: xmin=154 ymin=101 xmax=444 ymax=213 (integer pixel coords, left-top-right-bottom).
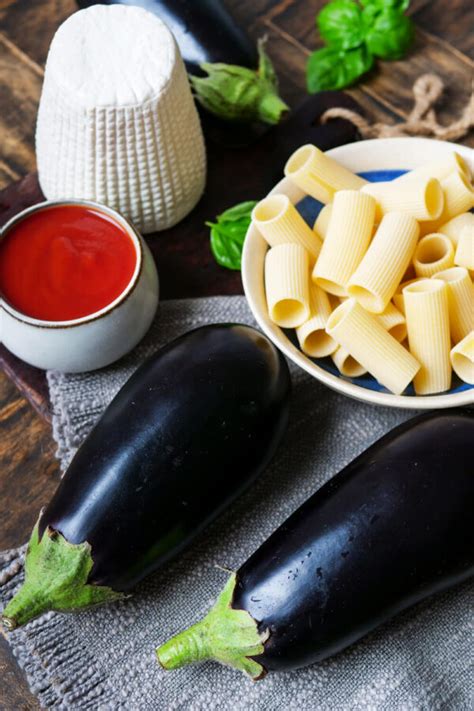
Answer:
xmin=242 ymin=137 xmax=474 ymax=410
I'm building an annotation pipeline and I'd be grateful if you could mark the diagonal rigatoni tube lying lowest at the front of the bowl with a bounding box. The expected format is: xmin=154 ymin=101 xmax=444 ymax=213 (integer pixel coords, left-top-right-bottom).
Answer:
xmin=326 ymin=299 xmax=420 ymax=395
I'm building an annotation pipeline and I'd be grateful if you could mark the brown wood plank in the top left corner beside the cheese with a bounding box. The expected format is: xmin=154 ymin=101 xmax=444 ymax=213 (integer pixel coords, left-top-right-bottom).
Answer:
xmin=0 ymin=0 xmax=77 ymax=68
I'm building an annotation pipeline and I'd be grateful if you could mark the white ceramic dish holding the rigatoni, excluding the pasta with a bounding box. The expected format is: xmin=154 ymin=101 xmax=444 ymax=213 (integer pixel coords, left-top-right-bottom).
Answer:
xmin=242 ymin=138 xmax=474 ymax=410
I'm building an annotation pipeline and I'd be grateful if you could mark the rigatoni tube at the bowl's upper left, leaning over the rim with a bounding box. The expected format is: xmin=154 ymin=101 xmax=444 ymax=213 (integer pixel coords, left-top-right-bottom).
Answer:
xmin=285 ymin=143 xmax=367 ymax=203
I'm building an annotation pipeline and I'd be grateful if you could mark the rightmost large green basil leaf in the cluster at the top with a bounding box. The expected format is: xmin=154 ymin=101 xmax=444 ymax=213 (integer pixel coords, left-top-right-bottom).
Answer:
xmin=366 ymin=9 xmax=415 ymax=59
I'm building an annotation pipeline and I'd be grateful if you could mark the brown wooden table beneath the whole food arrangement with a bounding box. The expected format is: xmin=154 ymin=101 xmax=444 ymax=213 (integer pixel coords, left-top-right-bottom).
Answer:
xmin=0 ymin=0 xmax=474 ymax=711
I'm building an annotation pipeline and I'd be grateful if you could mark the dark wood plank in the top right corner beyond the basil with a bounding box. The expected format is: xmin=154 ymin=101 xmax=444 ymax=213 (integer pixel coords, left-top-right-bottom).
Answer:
xmin=413 ymin=0 xmax=474 ymax=60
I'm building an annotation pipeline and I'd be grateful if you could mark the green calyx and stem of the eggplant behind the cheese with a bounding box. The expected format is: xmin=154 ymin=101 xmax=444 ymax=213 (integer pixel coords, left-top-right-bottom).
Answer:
xmin=189 ymin=39 xmax=288 ymax=124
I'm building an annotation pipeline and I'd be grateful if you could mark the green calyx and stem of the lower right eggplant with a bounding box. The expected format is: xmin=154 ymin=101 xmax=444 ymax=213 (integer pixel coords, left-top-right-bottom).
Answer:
xmin=156 ymin=573 xmax=270 ymax=681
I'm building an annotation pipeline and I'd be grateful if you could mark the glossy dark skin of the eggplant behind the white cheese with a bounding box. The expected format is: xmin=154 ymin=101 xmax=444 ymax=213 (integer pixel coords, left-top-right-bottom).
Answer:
xmin=78 ymin=0 xmax=258 ymax=73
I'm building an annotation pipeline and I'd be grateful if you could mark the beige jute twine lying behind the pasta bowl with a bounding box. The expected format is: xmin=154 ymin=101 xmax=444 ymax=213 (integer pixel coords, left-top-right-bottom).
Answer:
xmin=321 ymin=74 xmax=474 ymax=141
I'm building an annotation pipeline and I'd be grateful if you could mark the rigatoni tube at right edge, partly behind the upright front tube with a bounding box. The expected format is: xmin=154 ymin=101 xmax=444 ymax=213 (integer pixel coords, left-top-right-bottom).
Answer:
xmin=434 ymin=267 xmax=474 ymax=343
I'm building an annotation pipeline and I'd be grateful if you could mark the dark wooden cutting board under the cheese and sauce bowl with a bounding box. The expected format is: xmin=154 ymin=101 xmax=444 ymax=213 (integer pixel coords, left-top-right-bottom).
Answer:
xmin=0 ymin=92 xmax=360 ymax=420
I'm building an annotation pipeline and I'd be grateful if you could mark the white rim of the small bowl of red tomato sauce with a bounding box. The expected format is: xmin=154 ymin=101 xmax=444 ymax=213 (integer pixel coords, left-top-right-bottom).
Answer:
xmin=0 ymin=198 xmax=143 ymax=328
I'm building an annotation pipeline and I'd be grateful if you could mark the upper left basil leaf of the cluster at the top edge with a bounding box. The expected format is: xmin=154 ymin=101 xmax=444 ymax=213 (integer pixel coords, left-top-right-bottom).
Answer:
xmin=317 ymin=0 xmax=364 ymax=49
